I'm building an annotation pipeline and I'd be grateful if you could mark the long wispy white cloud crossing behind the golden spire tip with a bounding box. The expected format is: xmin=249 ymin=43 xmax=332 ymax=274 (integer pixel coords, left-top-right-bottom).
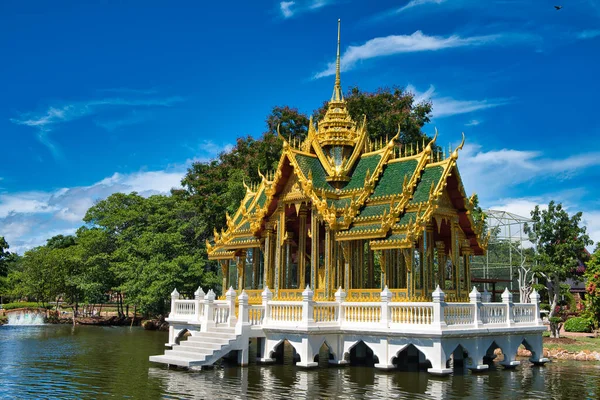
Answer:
xmin=314 ymin=31 xmax=531 ymax=79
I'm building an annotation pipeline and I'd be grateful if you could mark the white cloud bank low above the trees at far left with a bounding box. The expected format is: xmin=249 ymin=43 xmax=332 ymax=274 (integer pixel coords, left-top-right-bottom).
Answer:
xmin=0 ymin=168 xmax=185 ymax=253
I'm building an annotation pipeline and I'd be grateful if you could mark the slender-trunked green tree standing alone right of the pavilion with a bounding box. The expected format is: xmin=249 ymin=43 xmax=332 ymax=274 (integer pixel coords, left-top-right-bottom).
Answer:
xmin=524 ymin=201 xmax=592 ymax=337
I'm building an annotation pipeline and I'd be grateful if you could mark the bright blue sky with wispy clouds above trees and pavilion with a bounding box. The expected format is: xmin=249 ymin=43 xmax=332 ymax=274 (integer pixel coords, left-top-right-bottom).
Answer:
xmin=0 ymin=0 xmax=600 ymax=252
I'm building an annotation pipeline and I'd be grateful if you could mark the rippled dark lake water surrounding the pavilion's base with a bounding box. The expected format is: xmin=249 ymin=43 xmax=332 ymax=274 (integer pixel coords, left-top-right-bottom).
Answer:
xmin=0 ymin=325 xmax=600 ymax=400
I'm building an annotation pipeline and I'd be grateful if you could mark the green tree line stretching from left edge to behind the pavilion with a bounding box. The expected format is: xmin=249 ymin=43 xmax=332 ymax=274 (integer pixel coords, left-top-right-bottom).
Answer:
xmin=0 ymin=87 xmax=431 ymax=315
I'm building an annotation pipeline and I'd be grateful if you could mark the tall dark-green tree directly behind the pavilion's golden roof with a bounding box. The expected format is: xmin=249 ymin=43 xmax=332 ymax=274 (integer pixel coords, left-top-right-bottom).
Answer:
xmin=180 ymin=87 xmax=431 ymax=269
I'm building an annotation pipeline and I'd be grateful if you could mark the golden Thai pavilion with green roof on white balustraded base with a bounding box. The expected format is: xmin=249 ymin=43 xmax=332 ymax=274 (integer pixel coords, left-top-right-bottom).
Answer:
xmin=150 ymin=24 xmax=547 ymax=374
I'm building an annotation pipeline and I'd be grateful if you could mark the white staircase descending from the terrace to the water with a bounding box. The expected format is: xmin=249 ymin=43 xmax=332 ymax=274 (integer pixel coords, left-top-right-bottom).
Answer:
xmin=150 ymin=327 xmax=241 ymax=367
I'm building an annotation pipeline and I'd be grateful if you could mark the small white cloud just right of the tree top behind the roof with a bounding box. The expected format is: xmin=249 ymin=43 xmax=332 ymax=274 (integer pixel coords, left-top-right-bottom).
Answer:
xmin=406 ymin=85 xmax=510 ymax=118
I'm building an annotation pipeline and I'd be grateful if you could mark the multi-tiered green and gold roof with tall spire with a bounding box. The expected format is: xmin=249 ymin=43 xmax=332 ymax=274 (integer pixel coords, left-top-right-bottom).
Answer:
xmin=207 ymin=21 xmax=485 ymax=259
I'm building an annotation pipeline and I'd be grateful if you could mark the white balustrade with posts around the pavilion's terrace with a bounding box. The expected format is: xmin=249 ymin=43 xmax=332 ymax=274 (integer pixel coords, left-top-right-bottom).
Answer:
xmin=169 ymin=288 xmax=540 ymax=331
